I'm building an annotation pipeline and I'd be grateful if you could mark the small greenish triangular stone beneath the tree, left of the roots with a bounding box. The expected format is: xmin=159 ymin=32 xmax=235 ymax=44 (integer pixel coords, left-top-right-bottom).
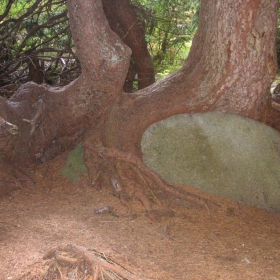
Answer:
xmin=61 ymin=142 xmax=87 ymax=181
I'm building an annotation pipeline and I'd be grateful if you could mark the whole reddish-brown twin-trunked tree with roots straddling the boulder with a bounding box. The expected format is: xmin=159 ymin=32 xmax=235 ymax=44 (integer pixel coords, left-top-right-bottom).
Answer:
xmin=0 ymin=0 xmax=278 ymax=210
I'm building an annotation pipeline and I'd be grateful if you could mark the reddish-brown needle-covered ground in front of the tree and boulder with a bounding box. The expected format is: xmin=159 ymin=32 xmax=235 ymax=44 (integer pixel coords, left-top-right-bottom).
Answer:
xmin=0 ymin=153 xmax=280 ymax=280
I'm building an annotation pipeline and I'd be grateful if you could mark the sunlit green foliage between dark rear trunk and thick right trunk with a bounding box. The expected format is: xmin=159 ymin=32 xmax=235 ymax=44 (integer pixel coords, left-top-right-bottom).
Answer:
xmin=132 ymin=0 xmax=200 ymax=78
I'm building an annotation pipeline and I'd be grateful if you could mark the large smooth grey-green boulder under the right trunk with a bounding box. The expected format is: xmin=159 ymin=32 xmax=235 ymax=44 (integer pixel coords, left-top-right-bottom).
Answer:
xmin=142 ymin=112 xmax=280 ymax=211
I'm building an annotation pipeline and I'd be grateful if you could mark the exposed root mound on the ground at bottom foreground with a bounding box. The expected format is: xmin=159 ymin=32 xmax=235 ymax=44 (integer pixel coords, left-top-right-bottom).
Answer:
xmin=21 ymin=244 xmax=153 ymax=280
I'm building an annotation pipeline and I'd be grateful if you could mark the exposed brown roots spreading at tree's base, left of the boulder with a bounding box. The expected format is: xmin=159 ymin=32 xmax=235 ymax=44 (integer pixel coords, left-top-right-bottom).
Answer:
xmin=85 ymin=143 xmax=221 ymax=215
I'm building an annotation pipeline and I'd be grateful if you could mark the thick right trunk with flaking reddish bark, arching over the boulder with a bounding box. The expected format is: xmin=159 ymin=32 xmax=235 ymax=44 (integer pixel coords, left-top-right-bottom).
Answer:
xmin=102 ymin=0 xmax=278 ymax=153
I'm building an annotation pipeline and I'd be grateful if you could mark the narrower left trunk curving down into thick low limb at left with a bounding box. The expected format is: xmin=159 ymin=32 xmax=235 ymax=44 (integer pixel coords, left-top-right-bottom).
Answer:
xmin=0 ymin=1 xmax=130 ymax=164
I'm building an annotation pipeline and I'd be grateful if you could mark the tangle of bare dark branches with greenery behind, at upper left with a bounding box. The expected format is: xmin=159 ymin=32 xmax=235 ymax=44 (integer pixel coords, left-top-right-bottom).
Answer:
xmin=0 ymin=0 xmax=74 ymax=88
